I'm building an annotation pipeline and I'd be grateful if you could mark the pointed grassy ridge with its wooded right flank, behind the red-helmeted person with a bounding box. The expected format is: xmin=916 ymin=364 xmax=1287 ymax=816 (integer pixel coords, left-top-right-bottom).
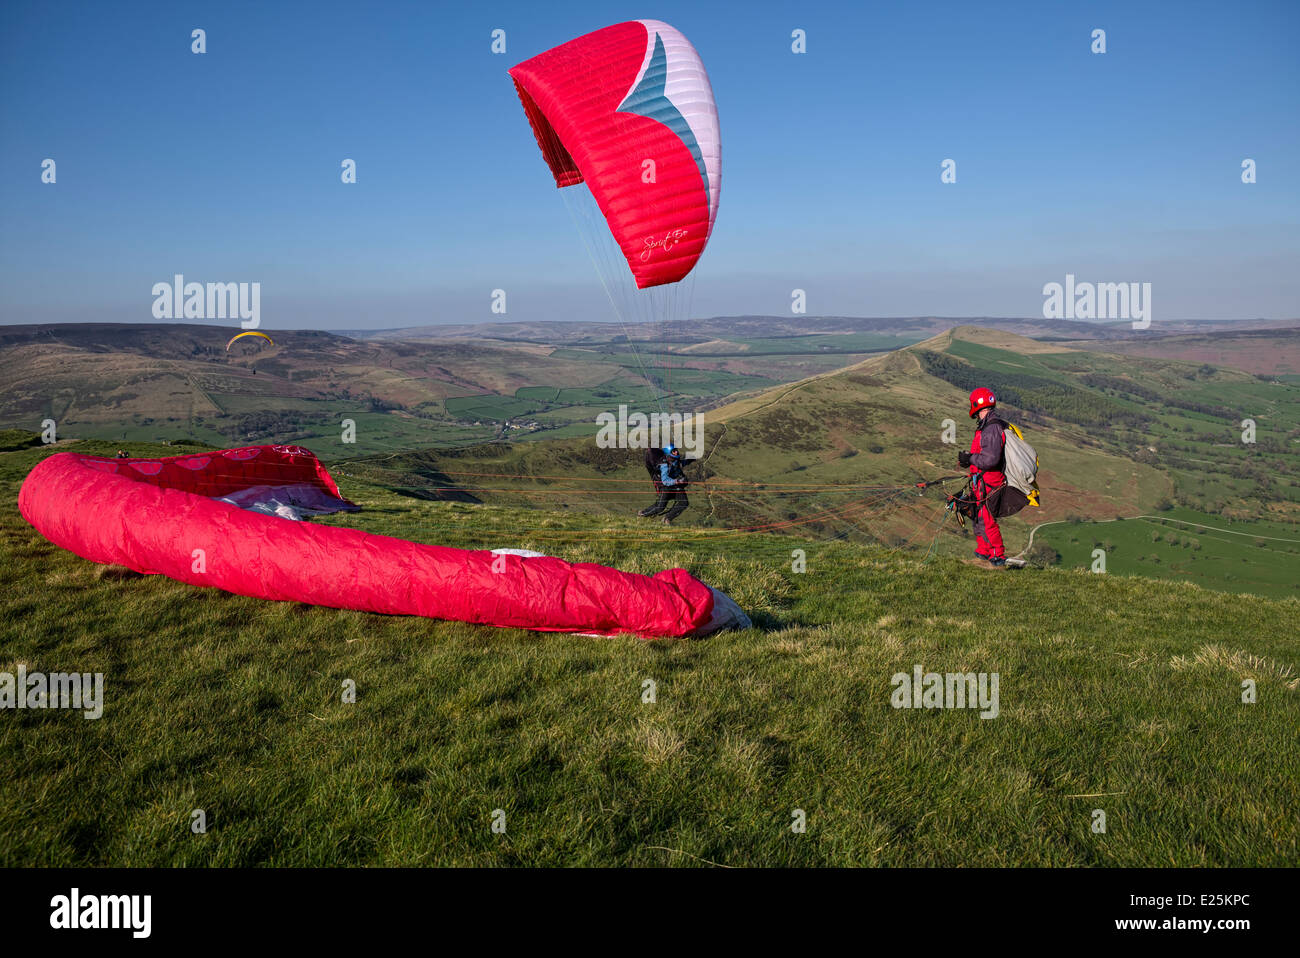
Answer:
xmin=327 ymin=326 xmax=1300 ymax=595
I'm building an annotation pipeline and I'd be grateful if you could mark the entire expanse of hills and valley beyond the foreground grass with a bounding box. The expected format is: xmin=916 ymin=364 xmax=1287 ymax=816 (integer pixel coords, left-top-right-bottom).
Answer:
xmin=0 ymin=320 xmax=1300 ymax=595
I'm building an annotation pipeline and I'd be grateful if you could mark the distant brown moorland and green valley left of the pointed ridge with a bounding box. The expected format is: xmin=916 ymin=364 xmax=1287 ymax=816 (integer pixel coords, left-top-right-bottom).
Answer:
xmin=0 ymin=324 xmax=899 ymax=454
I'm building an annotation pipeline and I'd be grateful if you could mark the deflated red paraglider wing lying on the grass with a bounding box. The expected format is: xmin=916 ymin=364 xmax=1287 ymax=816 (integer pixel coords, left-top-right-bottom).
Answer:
xmin=18 ymin=446 xmax=722 ymax=637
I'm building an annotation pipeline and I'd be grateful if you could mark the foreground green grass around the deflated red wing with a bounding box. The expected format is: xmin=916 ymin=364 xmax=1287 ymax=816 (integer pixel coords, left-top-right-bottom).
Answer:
xmin=0 ymin=443 xmax=1300 ymax=866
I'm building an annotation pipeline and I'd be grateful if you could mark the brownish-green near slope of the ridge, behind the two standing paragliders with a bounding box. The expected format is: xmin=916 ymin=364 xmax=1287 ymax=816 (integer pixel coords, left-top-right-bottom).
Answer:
xmin=353 ymin=332 xmax=1171 ymax=552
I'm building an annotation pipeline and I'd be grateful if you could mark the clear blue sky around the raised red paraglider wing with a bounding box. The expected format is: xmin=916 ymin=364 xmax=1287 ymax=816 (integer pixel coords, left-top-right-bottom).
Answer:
xmin=0 ymin=0 xmax=1300 ymax=329
